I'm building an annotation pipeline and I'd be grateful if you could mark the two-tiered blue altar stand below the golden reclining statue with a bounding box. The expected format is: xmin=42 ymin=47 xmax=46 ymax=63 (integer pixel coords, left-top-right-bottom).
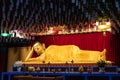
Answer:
xmin=1 ymin=66 xmax=120 ymax=80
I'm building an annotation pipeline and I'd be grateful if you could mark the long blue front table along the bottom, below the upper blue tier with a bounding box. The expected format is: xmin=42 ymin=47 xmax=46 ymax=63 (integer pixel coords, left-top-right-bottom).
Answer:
xmin=1 ymin=72 xmax=120 ymax=80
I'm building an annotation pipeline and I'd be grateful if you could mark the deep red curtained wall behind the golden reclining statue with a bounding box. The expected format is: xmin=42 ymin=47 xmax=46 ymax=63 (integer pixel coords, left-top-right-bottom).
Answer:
xmin=35 ymin=32 xmax=120 ymax=65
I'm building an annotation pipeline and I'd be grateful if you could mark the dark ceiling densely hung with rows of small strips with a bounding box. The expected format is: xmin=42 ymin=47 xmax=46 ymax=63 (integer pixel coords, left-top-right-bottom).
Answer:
xmin=0 ymin=0 xmax=120 ymax=33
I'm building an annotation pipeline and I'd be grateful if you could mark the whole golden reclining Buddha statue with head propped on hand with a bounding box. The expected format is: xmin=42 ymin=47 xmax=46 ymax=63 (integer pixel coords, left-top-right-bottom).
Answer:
xmin=25 ymin=42 xmax=106 ymax=63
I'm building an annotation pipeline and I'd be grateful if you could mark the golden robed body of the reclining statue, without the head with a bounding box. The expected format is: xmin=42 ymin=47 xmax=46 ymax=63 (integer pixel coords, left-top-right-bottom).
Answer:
xmin=39 ymin=45 xmax=105 ymax=63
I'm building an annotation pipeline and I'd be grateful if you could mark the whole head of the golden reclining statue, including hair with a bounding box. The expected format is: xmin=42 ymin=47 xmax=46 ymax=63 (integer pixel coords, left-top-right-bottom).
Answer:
xmin=33 ymin=42 xmax=45 ymax=55
